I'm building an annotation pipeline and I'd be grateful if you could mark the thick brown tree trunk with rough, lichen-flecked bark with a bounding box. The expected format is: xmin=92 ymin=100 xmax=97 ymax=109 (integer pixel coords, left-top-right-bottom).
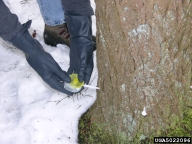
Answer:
xmin=89 ymin=0 xmax=192 ymax=139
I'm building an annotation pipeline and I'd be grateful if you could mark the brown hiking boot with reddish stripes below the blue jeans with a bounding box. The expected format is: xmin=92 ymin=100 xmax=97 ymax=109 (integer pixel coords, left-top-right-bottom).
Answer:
xmin=43 ymin=23 xmax=96 ymax=50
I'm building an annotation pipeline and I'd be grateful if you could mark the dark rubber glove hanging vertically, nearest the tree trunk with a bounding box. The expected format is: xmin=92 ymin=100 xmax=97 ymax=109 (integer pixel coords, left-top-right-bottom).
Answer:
xmin=65 ymin=13 xmax=93 ymax=84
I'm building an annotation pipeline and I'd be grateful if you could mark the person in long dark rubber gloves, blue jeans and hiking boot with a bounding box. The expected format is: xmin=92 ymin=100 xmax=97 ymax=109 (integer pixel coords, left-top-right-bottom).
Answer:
xmin=0 ymin=0 xmax=94 ymax=95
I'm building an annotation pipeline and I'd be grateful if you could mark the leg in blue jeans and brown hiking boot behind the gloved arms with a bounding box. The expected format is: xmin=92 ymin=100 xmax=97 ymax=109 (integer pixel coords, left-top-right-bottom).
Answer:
xmin=37 ymin=0 xmax=96 ymax=50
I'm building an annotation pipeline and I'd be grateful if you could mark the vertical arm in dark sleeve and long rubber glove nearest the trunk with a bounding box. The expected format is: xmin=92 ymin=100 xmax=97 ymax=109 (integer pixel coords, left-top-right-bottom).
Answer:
xmin=62 ymin=0 xmax=94 ymax=84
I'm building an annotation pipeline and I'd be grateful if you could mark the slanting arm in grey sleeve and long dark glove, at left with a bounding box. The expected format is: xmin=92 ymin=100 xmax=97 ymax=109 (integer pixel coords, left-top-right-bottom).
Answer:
xmin=0 ymin=1 xmax=73 ymax=95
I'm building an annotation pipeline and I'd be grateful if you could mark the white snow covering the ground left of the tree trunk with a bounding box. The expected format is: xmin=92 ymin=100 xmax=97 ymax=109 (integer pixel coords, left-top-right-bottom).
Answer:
xmin=0 ymin=0 xmax=97 ymax=144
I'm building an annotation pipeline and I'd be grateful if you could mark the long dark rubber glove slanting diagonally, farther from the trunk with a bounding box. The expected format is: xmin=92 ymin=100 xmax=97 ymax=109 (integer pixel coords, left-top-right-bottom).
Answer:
xmin=10 ymin=21 xmax=73 ymax=95
